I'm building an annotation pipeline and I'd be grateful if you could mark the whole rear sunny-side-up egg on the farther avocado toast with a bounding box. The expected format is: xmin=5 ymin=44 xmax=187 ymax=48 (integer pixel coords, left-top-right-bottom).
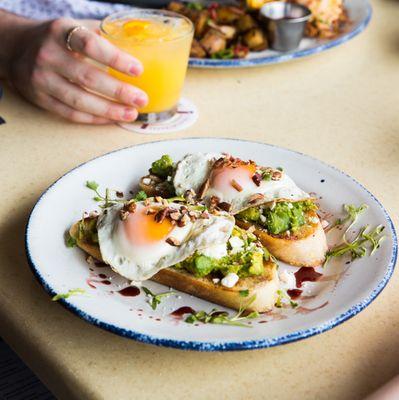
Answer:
xmin=173 ymin=153 xmax=309 ymax=214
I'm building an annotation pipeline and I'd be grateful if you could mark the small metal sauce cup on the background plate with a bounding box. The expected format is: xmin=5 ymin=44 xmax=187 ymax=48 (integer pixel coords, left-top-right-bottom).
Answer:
xmin=260 ymin=1 xmax=311 ymax=51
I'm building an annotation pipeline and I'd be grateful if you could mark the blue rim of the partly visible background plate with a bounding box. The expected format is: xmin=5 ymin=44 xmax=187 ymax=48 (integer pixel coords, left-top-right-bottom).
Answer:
xmin=188 ymin=0 xmax=373 ymax=68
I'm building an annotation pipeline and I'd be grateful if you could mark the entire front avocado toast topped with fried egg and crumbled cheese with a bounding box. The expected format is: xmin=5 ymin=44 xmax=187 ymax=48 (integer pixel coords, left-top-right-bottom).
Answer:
xmin=70 ymin=198 xmax=279 ymax=312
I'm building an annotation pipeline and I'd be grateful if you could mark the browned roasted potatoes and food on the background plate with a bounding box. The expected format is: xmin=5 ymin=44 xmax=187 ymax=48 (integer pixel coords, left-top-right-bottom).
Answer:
xmin=168 ymin=0 xmax=348 ymax=59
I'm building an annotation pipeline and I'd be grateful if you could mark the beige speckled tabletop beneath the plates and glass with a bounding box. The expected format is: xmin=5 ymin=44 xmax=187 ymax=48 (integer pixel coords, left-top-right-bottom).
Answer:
xmin=0 ymin=0 xmax=399 ymax=400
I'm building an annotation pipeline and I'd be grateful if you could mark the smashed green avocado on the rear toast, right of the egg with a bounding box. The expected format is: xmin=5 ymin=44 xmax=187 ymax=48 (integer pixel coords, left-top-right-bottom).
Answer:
xmin=237 ymin=200 xmax=317 ymax=235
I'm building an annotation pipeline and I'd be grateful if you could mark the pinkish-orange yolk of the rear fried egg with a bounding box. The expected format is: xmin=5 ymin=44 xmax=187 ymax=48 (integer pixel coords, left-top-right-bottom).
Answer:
xmin=210 ymin=164 xmax=256 ymax=193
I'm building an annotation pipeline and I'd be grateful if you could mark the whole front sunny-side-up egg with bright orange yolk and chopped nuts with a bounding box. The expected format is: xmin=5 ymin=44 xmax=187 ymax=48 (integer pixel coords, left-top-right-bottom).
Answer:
xmin=97 ymin=202 xmax=234 ymax=281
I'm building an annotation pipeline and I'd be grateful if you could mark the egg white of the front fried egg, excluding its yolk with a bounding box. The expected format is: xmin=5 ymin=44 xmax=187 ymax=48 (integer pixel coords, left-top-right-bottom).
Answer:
xmin=97 ymin=203 xmax=234 ymax=281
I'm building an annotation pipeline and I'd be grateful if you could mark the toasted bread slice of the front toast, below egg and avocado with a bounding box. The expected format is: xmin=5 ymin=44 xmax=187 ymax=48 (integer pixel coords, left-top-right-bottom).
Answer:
xmin=69 ymin=222 xmax=279 ymax=312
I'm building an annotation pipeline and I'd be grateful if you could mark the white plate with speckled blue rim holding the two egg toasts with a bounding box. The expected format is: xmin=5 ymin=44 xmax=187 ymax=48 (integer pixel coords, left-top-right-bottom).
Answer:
xmin=26 ymin=138 xmax=397 ymax=351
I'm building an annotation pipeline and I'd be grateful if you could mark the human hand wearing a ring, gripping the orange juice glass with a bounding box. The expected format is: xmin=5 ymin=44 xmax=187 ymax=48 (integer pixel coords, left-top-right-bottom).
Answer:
xmin=8 ymin=18 xmax=148 ymax=124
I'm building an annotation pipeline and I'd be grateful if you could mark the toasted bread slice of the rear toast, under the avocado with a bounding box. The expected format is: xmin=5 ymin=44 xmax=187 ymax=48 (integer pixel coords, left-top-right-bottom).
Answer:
xmin=236 ymin=213 xmax=327 ymax=267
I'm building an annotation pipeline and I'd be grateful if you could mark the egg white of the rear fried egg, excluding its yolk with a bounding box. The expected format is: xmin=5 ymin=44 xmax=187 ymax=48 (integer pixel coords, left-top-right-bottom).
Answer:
xmin=173 ymin=153 xmax=310 ymax=214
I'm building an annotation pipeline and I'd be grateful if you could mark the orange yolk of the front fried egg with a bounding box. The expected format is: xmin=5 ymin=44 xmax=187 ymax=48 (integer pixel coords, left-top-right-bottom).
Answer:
xmin=124 ymin=207 xmax=174 ymax=245
